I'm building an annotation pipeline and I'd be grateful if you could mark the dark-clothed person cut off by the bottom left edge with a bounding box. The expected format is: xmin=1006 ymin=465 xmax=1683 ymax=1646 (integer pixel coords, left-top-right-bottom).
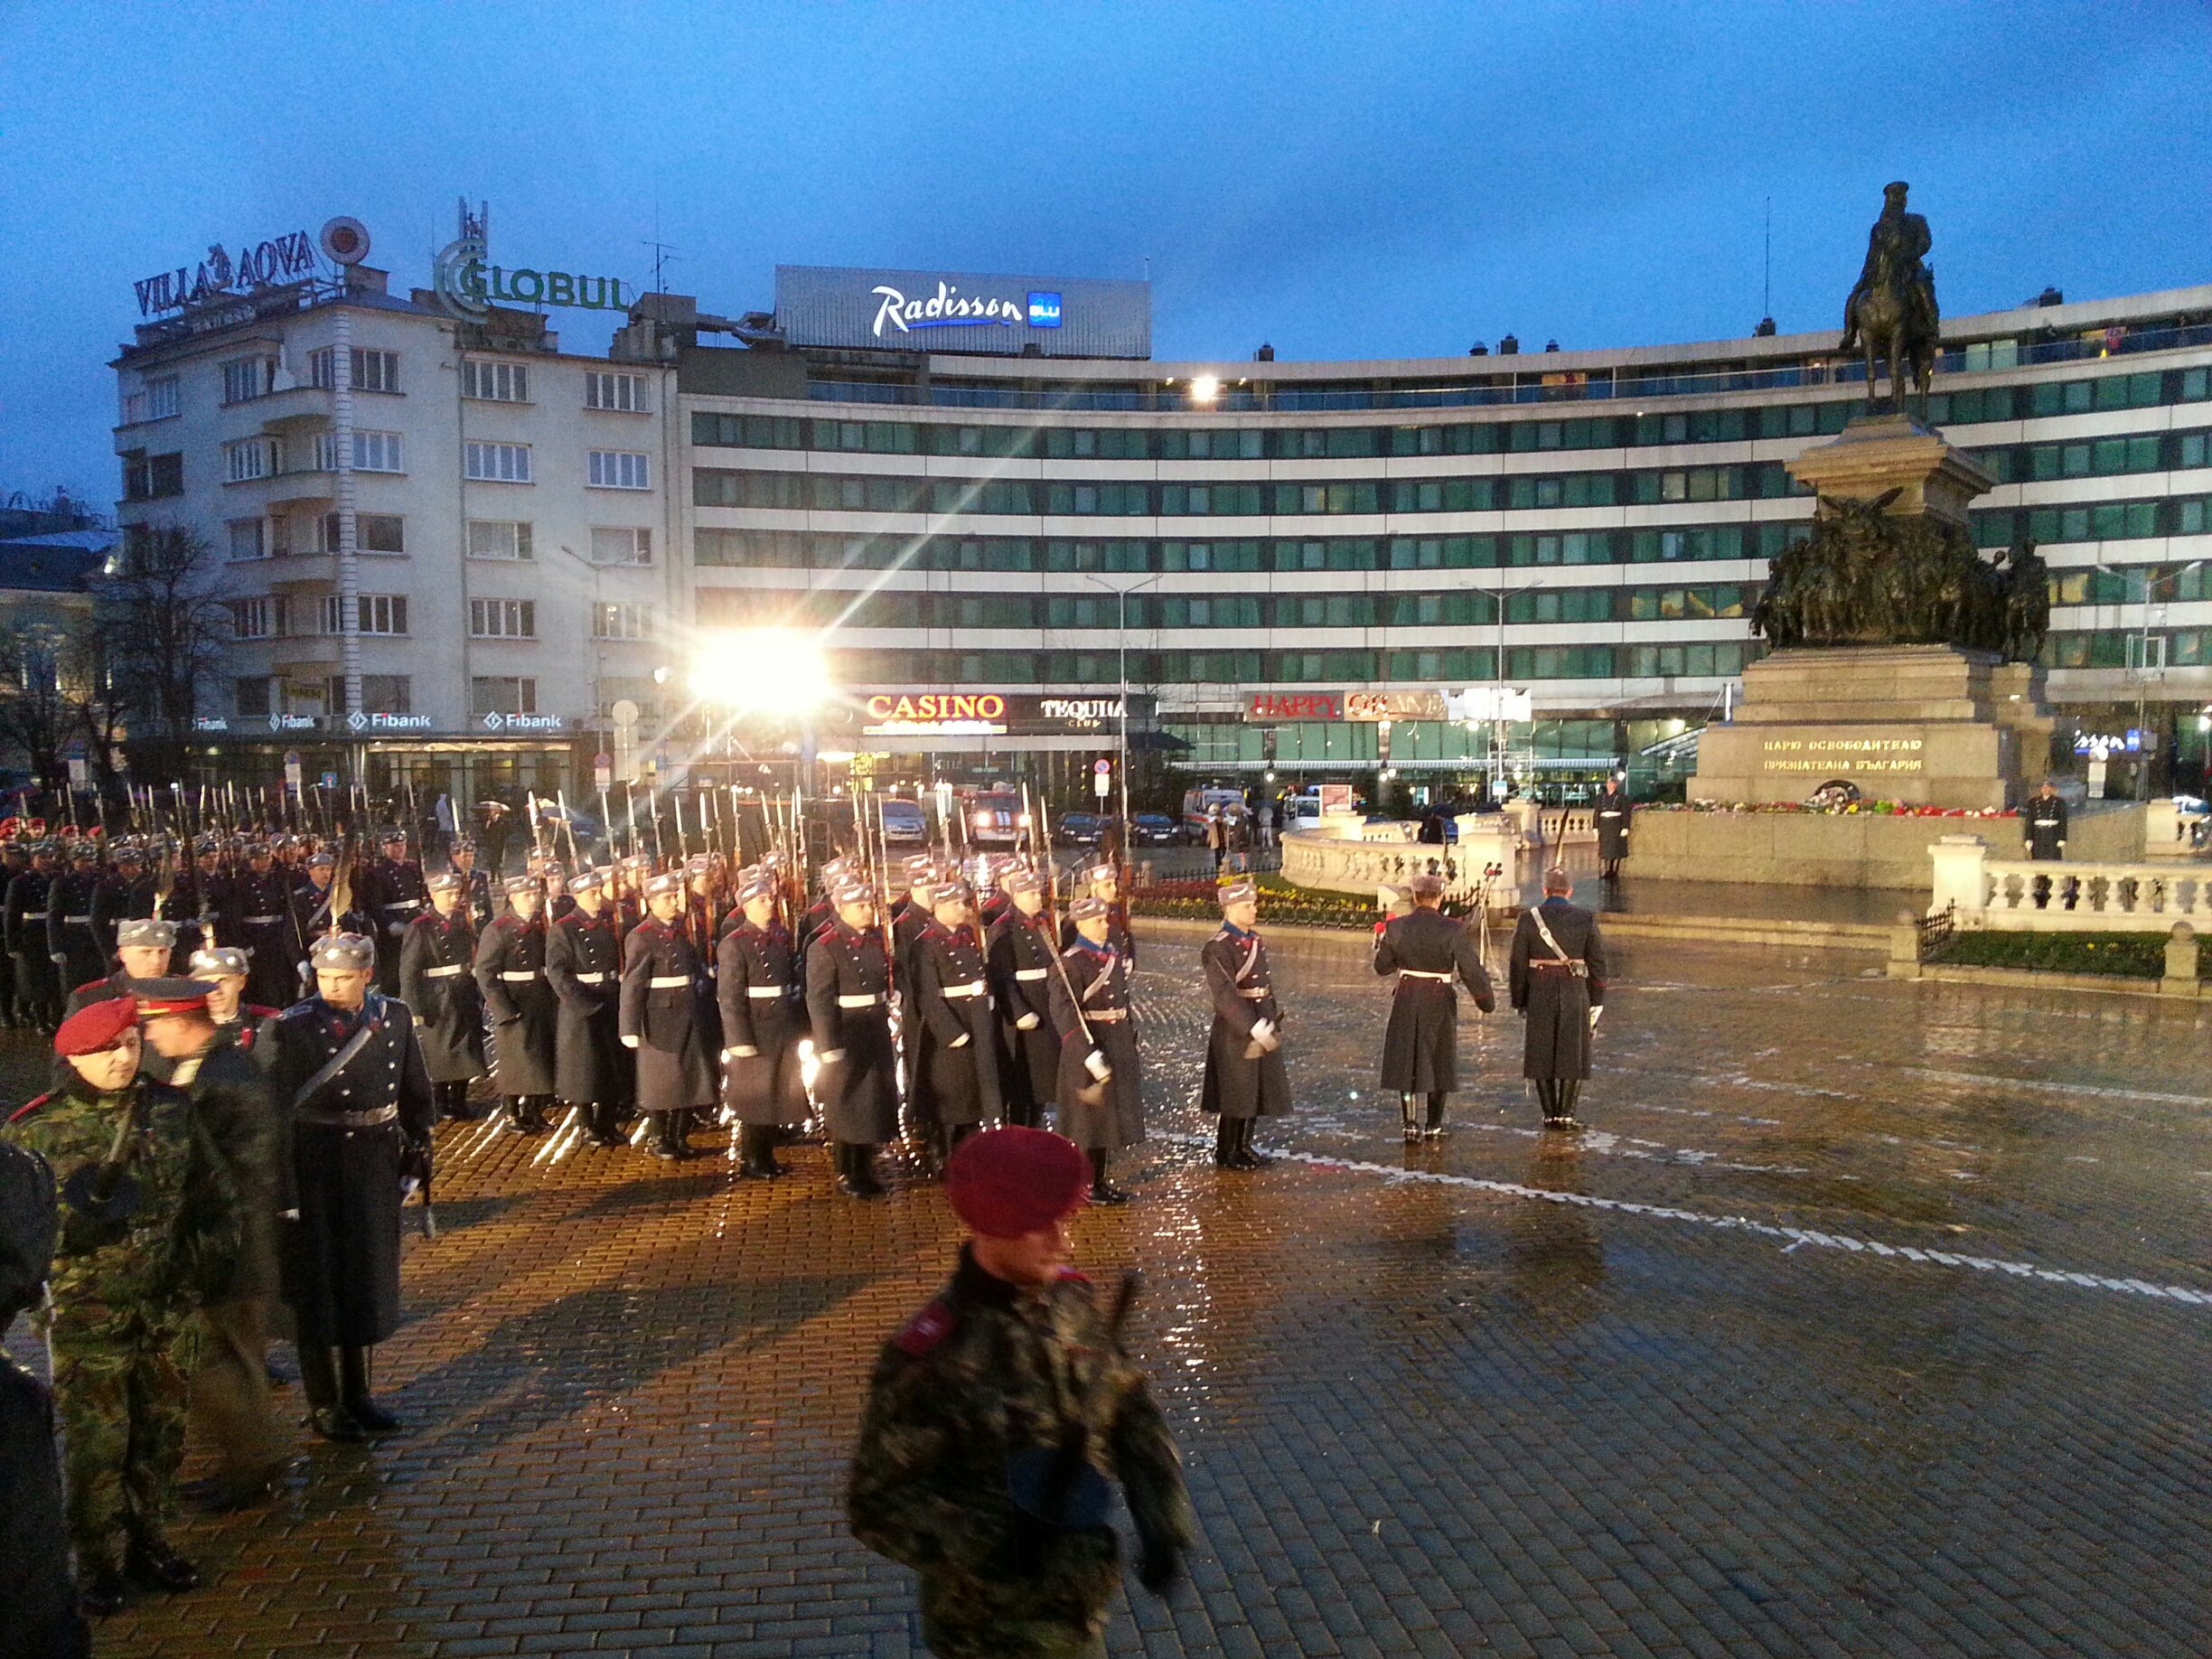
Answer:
xmin=0 ymin=1139 xmax=93 ymax=1659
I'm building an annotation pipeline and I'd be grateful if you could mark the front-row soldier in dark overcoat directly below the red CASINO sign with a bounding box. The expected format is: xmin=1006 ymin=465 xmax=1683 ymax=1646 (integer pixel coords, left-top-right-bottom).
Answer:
xmin=907 ymin=876 xmax=1002 ymax=1166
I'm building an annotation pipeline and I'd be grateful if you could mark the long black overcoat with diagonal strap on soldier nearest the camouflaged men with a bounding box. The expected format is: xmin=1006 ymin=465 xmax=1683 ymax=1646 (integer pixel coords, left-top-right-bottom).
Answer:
xmin=267 ymin=991 xmax=438 ymax=1347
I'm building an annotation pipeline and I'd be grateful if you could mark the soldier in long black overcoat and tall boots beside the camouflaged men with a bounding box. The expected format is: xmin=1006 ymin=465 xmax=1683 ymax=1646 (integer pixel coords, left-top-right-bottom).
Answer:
xmin=270 ymin=933 xmax=438 ymax=1440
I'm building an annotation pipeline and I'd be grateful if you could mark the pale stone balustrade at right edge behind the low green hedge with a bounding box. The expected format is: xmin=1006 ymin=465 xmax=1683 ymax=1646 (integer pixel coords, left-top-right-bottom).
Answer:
xmin=1929 ymin=836 xmax=2212 ymax=933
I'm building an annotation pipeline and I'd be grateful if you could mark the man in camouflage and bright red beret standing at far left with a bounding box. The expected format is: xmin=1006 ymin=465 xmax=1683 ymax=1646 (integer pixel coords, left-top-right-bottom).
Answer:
xmin=9 ymin=996 xmax=220 ymax=1617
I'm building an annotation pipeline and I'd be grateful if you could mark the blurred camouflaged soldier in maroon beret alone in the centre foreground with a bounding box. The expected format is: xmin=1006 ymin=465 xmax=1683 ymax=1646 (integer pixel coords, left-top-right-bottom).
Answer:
xmin=845 ymin=1128 xmax=1196 ymax=1659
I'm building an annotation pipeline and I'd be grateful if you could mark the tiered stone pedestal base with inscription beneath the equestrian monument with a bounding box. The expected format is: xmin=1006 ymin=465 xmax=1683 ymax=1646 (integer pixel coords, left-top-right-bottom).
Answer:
xmin=1688 ymin=646 xmax=2053 ymax=811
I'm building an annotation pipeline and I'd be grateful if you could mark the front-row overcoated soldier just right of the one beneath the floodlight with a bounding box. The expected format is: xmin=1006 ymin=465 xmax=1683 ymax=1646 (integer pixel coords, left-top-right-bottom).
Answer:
xmin=808 ymin=874 xmax=898 ymax=1199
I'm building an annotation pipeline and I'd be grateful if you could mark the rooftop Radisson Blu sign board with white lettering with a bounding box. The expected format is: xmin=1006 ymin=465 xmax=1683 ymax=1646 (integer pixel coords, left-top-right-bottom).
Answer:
xmin=776 ymin=266 xmax=1152 ymax=359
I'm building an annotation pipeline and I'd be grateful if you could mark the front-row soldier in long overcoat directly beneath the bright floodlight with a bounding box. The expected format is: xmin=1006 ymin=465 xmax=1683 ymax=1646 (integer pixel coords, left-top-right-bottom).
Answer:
xmin=715 ymin=869 xmax=808 ymax=1181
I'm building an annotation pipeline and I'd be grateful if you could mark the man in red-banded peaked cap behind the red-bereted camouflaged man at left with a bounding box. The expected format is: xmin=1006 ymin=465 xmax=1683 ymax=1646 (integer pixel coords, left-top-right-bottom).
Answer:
xmin=133 ymin=978 xmax=292 ymax=1515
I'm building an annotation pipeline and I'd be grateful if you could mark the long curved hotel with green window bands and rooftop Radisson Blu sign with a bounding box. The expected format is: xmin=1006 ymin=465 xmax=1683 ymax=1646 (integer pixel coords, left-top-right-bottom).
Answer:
xmin=680 ymin=267 xmax=2212 ymax=799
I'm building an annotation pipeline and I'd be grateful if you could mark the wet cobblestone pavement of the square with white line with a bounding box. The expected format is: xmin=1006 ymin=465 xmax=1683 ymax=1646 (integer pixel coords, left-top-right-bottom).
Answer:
xmin=11 ymin=927 xmax=2212 ymax=1659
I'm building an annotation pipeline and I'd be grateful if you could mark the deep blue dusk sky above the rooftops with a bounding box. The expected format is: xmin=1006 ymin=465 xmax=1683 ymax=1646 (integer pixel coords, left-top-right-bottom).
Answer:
xmin=0 ymin=0 xmax=2212 ymax=507
